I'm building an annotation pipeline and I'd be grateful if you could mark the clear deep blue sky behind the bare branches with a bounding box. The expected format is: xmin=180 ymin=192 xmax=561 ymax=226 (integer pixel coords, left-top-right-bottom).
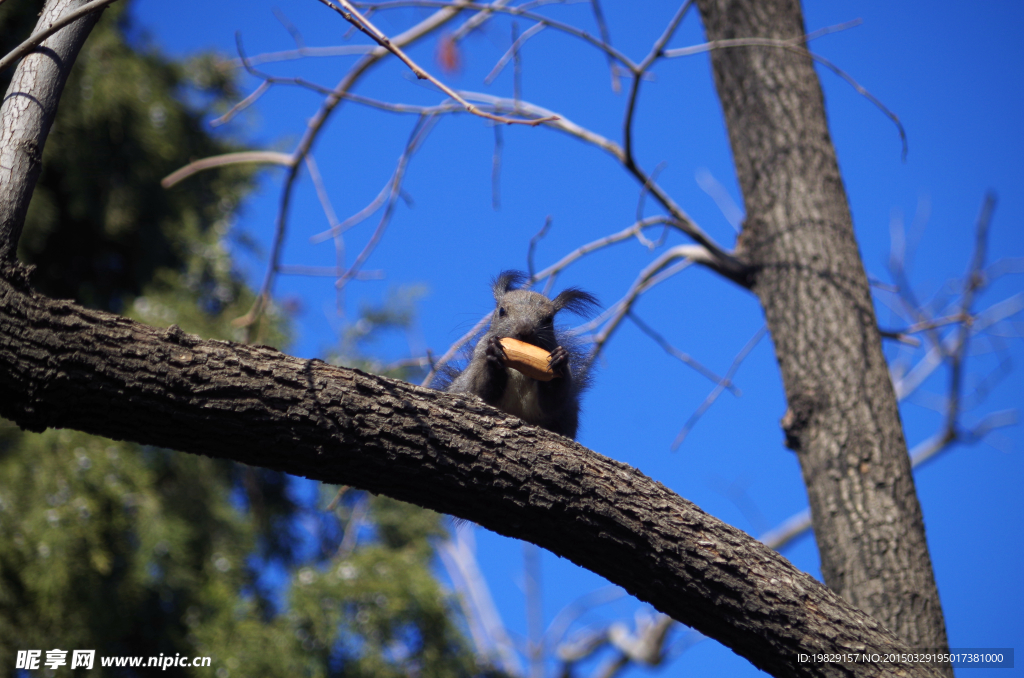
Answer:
xmin=135 ymin=0 xmax=1024 ymax=675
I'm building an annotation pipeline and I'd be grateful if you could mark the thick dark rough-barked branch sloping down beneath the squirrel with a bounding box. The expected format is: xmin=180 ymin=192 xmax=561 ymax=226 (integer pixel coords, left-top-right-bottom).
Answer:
xmin=0 ymin=281 xmax=938 ymax=676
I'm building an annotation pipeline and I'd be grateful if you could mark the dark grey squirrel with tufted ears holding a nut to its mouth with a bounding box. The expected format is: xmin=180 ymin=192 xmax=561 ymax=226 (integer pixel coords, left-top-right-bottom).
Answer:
xmin=444 ymin=270 xmax=598 ymax=438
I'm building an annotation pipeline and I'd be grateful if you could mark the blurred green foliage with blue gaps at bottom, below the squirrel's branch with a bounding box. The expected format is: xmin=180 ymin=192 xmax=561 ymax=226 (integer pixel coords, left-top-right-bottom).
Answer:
xmin=192 ymin=493 xmax=494 ymax=678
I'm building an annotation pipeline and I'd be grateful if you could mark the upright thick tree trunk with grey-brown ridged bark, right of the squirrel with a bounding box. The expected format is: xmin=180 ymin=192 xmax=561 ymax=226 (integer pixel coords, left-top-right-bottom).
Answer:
xmin=697 ymin=0 xmax=952 ymax=663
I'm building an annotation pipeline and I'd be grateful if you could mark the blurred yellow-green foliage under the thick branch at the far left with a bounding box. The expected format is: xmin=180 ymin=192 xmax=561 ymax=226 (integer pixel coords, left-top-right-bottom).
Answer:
xmin=0 ymin=424 xmax=254 ymax=670
